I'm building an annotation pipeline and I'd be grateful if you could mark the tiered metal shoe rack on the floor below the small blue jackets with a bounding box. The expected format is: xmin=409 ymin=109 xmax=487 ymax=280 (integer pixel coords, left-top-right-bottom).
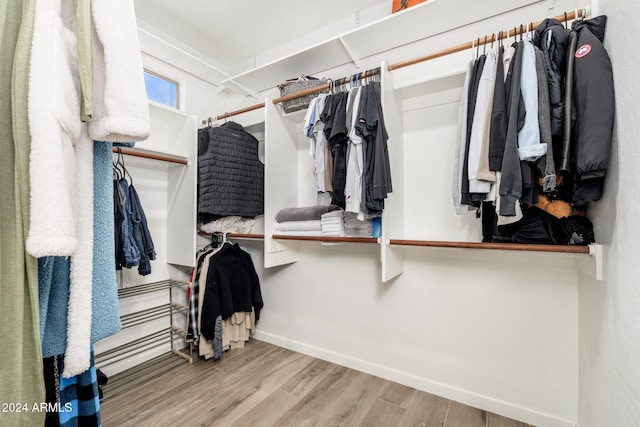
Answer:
xmin=96 ymin=279 xmax=193 ymax=367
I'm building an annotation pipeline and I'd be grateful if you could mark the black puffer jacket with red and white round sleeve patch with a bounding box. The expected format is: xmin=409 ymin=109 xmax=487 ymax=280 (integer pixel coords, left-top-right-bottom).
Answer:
xmin=567 ymin=16 xmax=615 ymax=205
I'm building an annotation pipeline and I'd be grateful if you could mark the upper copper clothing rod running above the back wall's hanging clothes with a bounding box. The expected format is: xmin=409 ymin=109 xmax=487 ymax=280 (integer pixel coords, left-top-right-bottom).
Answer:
xmin=202 ymin=9 xmax=586 ymax=125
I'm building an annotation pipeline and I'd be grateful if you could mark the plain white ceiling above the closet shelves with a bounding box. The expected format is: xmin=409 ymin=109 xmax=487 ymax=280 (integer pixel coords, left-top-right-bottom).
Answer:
xmin=134 ymin=0 xmax=392 ymax=73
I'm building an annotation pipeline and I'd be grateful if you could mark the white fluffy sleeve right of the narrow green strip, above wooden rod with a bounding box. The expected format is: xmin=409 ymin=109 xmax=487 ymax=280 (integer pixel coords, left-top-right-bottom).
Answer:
xmin=89 ymin=0 xmax=150 ymax=142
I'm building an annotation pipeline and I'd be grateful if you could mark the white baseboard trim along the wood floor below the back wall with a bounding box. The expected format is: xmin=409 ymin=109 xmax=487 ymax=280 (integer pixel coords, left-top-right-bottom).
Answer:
xmin=254 ymin=330 xmax=577 ymax=427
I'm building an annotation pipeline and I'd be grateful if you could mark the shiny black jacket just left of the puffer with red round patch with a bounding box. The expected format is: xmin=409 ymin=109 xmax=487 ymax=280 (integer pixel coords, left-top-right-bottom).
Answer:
xmin=533 ymin=18 xmax=569 ymax=135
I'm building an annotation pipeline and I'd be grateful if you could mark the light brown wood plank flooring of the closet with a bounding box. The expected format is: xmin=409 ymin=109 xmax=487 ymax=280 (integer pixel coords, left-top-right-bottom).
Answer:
xmin=101 ymin=340 xmax=530 ymax=427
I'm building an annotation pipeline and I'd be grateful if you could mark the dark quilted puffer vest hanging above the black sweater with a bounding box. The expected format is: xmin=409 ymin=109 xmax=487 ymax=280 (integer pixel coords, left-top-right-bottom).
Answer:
xmin=198 ymin=122 xmax=264 ymax=219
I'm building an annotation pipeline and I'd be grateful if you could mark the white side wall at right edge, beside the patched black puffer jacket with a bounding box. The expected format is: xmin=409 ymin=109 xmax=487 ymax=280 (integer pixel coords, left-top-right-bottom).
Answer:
xmin=579 ymin=0 xmax=640 ymax=427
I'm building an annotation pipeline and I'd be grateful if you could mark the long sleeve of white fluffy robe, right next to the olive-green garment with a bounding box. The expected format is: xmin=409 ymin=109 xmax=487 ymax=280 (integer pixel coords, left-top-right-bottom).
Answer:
xmin=26 ymin=0 xmax=82 ymax=257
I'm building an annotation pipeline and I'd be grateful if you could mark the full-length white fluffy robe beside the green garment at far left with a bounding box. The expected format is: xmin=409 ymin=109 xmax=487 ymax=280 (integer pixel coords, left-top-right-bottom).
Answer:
xmin=27 ymin=0 xmax=93 ymax=377
